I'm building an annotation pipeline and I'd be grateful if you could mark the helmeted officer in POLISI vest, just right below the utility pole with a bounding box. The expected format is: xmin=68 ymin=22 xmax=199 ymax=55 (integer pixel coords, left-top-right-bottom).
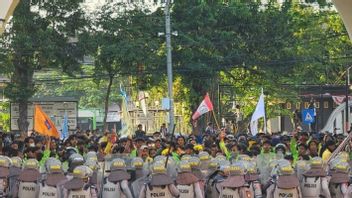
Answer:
xmin=176 ymin=161 xmax=204 ymax=198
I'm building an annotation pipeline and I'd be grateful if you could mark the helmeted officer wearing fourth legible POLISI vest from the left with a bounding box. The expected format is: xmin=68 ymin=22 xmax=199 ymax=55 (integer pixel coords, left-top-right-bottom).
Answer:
xmin=102 ymin=158 xmax=132 ymax=198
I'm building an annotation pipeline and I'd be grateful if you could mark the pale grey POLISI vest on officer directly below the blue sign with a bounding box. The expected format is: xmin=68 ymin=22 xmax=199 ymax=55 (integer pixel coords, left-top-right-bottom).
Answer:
xmin=301 ymin=176 xmax=321 ymax=198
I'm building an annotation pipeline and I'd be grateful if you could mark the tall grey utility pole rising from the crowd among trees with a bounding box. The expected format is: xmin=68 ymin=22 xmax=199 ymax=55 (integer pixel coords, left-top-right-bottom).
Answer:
xmin=165 ymin=0 xmax=175 ymax=135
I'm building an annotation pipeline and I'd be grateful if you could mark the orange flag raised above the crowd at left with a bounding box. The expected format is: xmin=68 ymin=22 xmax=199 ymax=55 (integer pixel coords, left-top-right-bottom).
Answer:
xmin=34 ymin=105 xmax=60 ymax=138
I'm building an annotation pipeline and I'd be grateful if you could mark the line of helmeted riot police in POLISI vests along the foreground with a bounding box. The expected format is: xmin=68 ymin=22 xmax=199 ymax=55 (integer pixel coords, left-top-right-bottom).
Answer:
xmin=0 ymin=151 xmax=352 ymax=198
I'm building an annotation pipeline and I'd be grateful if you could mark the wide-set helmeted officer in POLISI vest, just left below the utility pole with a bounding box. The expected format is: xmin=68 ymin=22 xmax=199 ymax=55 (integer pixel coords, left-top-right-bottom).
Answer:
xmin=139 ymin=161 xmax=180 ymax=198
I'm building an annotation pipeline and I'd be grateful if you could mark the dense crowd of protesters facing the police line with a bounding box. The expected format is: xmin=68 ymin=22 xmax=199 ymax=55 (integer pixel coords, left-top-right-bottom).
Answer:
xmin=0 ymin=125 xmax=351 ymax=197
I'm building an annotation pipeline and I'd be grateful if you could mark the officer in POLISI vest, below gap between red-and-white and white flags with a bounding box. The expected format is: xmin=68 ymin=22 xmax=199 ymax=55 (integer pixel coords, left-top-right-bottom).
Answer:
xmin=220 ymin=161 xmax=253 ymax=197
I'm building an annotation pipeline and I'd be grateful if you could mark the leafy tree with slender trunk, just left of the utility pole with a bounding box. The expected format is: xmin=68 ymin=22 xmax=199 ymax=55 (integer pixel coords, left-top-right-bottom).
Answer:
xmin=81 ymin=3 xmax=159 ymax=130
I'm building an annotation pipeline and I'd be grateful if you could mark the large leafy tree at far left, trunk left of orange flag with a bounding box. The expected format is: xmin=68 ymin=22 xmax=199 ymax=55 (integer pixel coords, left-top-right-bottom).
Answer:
xmin=0 ymin=0 xmax=85 ymax=133
